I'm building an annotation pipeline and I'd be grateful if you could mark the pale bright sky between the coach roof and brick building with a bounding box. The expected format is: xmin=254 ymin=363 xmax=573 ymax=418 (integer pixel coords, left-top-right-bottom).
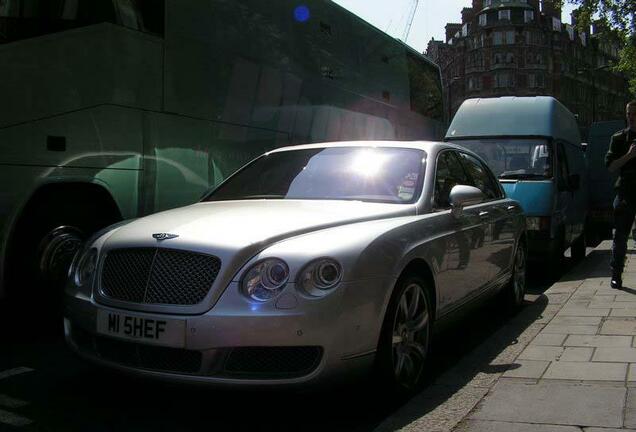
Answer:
xmin=333 ymin=0 xmax=573 ymax=52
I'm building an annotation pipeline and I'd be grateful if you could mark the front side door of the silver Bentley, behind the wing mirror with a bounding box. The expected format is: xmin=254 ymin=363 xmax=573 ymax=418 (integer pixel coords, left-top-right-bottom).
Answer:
xmin=433 ymin=150 xmax=490 ymax=310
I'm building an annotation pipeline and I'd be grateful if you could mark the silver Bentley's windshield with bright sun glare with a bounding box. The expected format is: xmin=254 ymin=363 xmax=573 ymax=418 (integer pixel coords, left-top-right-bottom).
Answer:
xmin=205 ymin=147 xmax=425 ymax=204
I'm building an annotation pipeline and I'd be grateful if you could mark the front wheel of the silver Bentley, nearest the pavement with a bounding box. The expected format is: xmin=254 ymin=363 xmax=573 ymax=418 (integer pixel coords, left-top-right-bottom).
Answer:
xmin=376 ymin=276 xmax=433 ymax=395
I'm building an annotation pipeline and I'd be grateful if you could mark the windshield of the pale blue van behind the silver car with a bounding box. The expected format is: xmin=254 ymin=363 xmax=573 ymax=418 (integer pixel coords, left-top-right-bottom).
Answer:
xmin=453 ymin=138 xmax=553 ymax=180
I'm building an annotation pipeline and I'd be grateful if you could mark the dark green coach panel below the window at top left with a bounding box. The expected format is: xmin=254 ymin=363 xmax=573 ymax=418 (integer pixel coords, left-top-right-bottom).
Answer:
xmin=0 ymin=23 xmax=163 ymax=127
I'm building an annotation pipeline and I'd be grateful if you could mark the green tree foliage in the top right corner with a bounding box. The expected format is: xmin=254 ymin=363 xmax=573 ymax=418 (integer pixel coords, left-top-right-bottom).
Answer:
xmin=556 ymin=0 xmax=636 ymax=94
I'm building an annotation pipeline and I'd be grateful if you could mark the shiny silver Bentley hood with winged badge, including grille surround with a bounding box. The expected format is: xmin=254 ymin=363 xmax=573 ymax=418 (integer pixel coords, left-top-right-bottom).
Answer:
xmin=99 ymin=200 xmax=416 ymax=314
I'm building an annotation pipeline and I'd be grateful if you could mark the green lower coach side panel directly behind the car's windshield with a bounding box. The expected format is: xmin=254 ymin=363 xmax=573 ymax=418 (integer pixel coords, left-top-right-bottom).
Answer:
xmin=143 ymin=113 xmax=289 ymax=214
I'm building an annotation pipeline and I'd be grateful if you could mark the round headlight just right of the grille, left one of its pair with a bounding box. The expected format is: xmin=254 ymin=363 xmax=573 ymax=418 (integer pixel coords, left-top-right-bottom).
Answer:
xmin=241 ymin=258 xmax=289 ymax=301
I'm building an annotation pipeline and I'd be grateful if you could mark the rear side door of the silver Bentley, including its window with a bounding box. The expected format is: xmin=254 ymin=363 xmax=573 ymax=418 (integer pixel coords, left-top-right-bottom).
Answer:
xmin=460 ymin=152 xmax=515 ymax=285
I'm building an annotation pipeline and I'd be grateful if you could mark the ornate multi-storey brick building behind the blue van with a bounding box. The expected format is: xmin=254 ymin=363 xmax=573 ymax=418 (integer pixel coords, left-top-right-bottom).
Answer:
xmin=425 ymin=0 xmax=629 ymax=133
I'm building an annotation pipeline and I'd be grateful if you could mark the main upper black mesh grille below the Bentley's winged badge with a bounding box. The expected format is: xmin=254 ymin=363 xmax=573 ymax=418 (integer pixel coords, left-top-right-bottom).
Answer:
xmin=100 ymin=248 xmax=221 ymax=305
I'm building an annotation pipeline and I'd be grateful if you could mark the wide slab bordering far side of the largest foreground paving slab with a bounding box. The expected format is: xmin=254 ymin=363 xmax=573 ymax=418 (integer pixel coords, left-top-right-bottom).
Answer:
xmin=543 ymin=361 xmax=628 ymax=381
